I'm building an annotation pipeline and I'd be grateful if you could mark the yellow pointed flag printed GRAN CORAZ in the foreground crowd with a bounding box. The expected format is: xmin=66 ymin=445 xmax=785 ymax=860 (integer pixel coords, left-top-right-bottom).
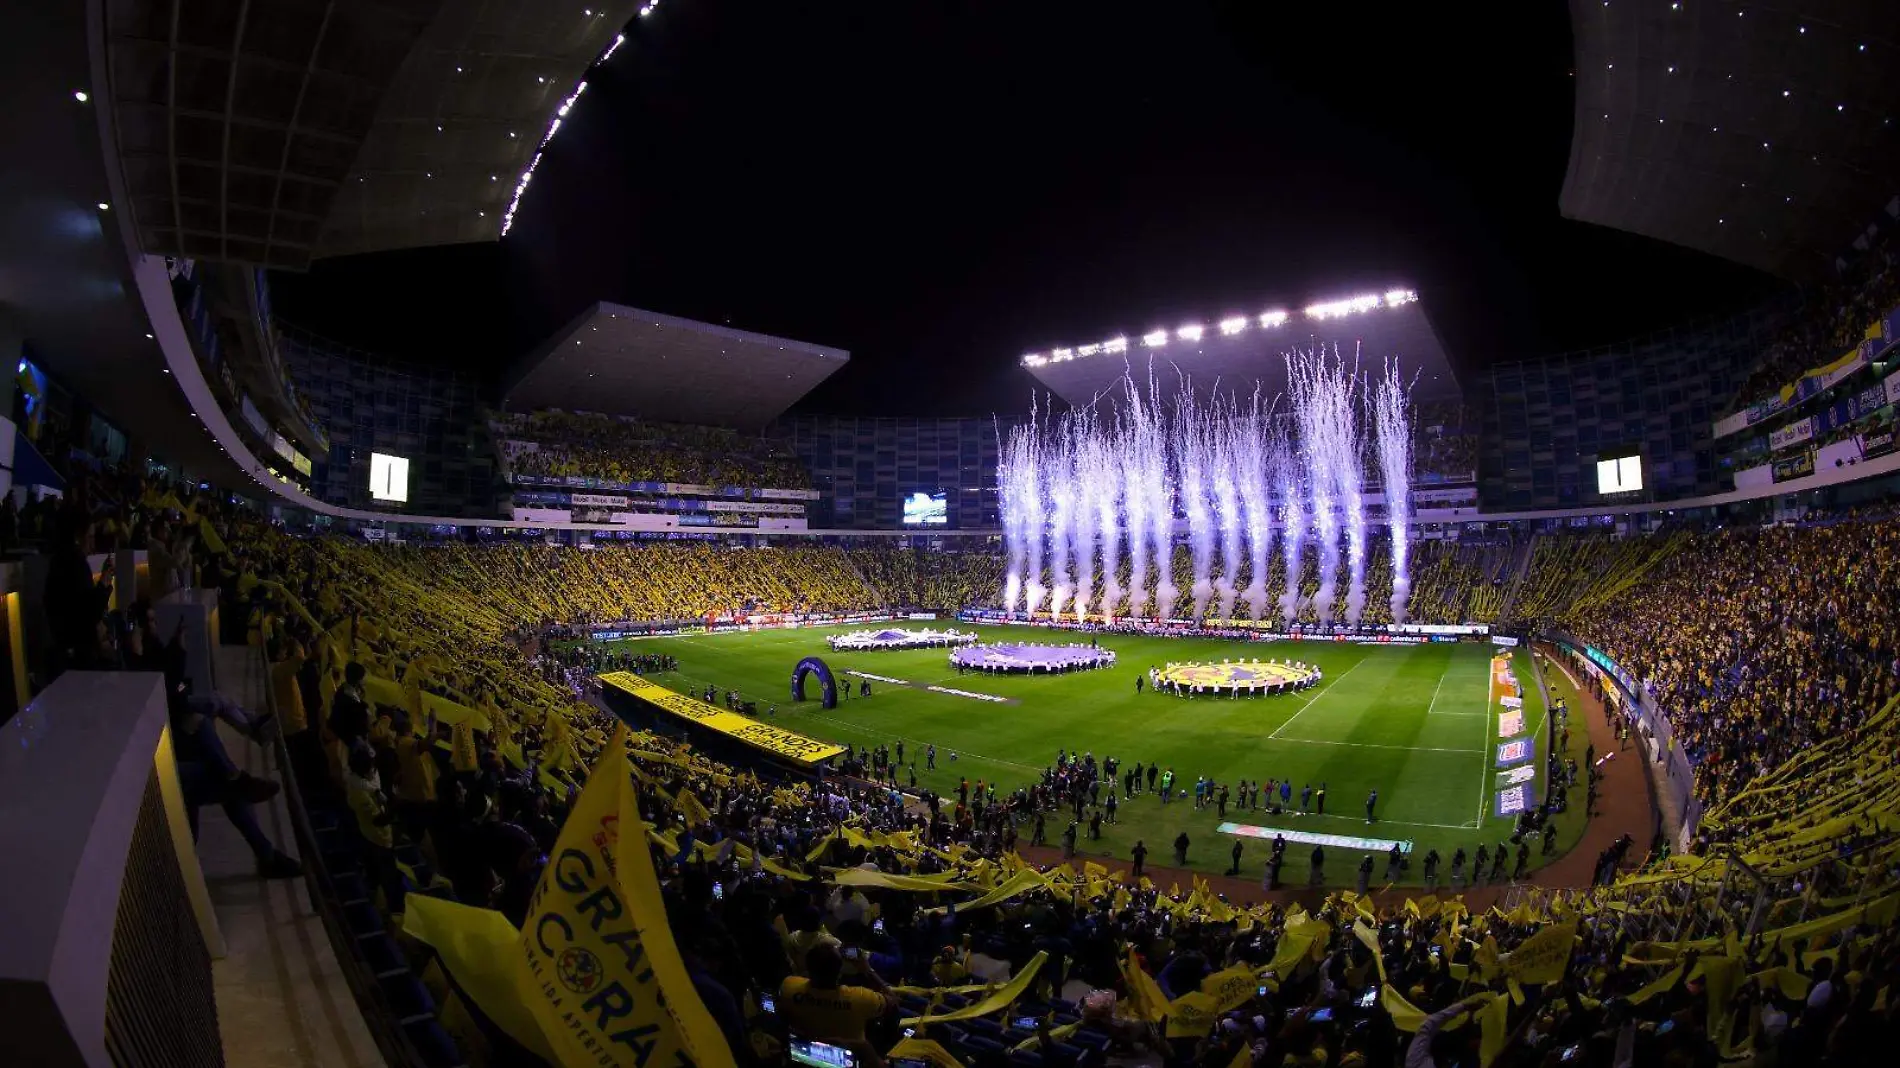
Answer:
xmin=515 ymin=728 xmax=733 ymax=1068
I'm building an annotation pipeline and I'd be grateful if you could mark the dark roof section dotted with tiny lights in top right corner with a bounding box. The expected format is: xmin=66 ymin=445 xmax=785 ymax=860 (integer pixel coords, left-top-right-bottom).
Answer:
xmin=1560 ymin=0 xmax=1900 ymax=279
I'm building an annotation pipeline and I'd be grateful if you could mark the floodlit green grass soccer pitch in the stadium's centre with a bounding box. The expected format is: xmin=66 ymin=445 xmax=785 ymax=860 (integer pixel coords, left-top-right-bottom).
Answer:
xmin=604 ymin=627 xmax=1587 ymax=887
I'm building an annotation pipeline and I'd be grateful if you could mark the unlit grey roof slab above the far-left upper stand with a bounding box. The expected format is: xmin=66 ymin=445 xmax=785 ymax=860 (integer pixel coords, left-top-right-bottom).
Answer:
xmin=502 ymin=302 xmax=851 ymax=429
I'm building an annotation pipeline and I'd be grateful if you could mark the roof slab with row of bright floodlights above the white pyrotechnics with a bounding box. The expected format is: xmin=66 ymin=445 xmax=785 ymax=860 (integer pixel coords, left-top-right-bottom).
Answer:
xmin=1022 ymin=289 xmax=1457 ymax=405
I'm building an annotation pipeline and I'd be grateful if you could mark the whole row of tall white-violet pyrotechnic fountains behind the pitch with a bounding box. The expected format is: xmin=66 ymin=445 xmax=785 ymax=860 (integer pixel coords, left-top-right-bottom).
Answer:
xmin=998 ymin=350 xmax=1412 ymax=623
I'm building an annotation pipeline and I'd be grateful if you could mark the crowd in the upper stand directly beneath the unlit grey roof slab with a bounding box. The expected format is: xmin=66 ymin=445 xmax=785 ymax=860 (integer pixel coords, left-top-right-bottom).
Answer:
xmin=494 ymin=410 xmax=811 ymax=490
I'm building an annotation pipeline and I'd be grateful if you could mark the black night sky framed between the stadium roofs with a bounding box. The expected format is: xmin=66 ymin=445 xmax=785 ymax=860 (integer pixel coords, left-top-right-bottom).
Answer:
xmin=276 ymin=0 xmax=1771 ymax=414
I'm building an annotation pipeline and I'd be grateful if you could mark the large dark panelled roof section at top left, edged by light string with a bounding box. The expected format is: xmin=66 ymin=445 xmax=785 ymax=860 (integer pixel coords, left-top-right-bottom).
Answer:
xmin=97 ymin=0 xmax=638 ymax=270
